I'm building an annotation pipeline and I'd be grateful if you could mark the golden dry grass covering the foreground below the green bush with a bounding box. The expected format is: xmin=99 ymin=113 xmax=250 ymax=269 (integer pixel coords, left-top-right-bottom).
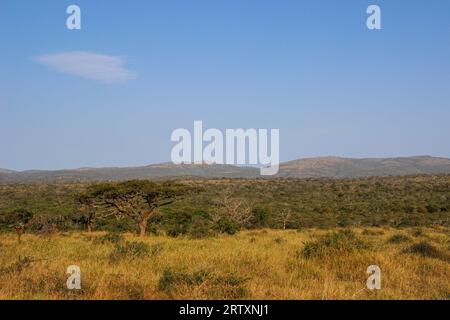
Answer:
xmin=0 ymin=228 xmax=450 ymax=299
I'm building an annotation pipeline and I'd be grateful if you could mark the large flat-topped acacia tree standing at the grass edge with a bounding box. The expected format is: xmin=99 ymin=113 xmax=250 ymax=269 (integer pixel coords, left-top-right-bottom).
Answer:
xmin=91 ymin=180 xmax=188 ymax=237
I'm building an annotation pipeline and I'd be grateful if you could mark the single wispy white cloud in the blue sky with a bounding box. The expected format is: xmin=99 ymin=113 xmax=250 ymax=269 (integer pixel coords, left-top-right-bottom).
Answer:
xmin=35 ymin=51 xmax=137 ymax=83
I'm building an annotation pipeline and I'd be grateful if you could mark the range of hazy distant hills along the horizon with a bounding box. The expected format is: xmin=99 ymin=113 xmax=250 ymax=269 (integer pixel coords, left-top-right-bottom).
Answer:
xmin=0 ymin=156 xmax=450 ymax=183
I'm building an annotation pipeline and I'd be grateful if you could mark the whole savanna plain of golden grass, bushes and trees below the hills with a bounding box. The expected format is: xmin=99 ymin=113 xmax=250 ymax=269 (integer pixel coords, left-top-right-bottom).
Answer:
xmin=0 ymin=175 xmax=450 ymax=299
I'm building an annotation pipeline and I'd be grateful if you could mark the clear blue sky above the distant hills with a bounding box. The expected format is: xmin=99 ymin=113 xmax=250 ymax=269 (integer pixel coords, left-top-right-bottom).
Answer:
xmin=0 ymin=0 xmax=450 ymax=170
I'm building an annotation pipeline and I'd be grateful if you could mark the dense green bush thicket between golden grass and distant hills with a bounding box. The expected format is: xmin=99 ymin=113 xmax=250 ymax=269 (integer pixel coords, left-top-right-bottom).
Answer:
xmin=0 ymin=175 xmax=450 ymax=237
